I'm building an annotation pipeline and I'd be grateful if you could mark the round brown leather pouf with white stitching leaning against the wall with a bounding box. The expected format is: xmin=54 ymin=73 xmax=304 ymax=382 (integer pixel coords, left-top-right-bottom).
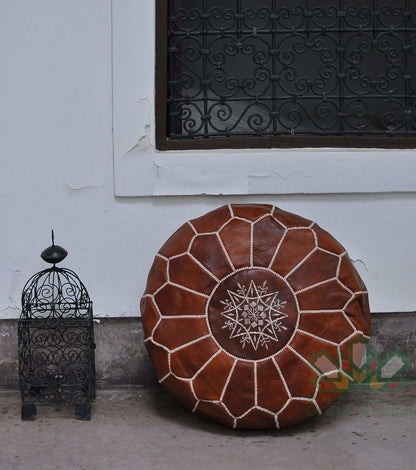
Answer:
xmin=141 ymin=204 xmax=370 ymax=428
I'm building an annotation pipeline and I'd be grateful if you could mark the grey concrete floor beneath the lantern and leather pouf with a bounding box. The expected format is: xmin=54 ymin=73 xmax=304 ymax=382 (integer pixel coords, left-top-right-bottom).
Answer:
xmin=0 ymin=382 xmax=416 ymax=470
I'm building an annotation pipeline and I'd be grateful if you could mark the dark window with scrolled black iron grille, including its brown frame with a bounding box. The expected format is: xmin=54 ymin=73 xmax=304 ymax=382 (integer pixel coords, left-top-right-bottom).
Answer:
xmin=156 ymin=0 xmax=416 ymax=149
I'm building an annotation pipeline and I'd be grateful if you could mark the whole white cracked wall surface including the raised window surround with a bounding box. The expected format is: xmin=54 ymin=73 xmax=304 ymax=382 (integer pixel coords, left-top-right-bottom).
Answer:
xmin=0 ymin=0 xmax=416 ymax=319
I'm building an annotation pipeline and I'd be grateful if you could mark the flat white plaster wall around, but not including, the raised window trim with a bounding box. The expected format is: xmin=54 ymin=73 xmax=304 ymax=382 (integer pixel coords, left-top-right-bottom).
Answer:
xmin=0 ymin=0 xmax=416 ymax=319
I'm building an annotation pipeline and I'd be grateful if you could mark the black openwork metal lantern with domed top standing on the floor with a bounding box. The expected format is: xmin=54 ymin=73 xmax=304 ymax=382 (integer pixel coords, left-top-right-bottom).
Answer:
xmin=18 ymin=231 xmax=95 ymax=420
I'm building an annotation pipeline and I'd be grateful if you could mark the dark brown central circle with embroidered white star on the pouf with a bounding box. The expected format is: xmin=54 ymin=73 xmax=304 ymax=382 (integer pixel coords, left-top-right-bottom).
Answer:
xmin=207 ymin=268 xmax=299 ymax=360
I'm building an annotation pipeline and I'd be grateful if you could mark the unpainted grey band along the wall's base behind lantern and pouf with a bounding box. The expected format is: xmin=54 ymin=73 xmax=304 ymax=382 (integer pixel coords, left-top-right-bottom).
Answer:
xmin=0 ymin=313 xmax=416 ymax=390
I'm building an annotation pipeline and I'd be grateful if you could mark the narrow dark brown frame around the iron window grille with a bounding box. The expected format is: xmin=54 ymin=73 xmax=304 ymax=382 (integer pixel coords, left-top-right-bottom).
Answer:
xmin=155 ymin=0 xmax=416 ymax=151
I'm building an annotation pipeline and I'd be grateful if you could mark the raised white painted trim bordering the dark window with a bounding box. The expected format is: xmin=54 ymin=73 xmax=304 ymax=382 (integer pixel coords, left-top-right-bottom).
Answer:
xmin=112 ymin=0 xmax=416 ymax=196
